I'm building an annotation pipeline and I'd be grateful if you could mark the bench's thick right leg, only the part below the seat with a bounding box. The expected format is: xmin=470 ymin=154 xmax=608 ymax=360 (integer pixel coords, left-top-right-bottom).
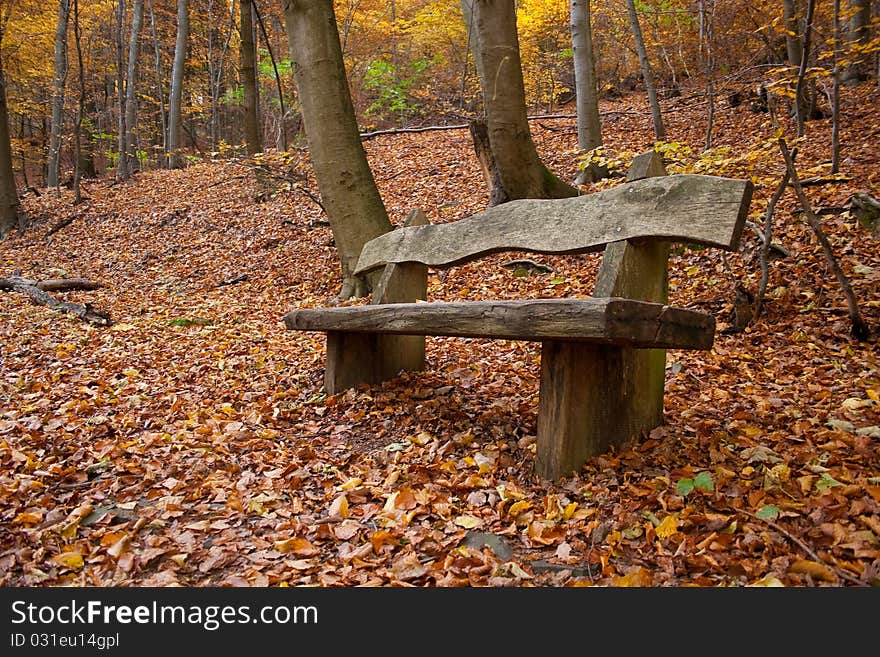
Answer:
xmin=535 ymin=341 xmax=665 ymax=479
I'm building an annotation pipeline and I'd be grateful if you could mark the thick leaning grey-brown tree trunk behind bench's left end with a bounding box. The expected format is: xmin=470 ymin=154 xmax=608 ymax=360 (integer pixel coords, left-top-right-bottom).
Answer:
xmin=284 ymin=0 xmax=391 ymax=298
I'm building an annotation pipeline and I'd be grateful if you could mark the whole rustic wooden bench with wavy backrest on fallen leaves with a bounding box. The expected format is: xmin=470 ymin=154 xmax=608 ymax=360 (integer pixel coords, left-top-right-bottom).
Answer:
xmin=284 ymin=151 xmax=752 ymax=479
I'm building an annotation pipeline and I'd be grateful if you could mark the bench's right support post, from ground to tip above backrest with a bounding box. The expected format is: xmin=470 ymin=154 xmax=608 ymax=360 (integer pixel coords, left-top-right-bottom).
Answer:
xmin=536 ymin=151 xmax=669 ymax=478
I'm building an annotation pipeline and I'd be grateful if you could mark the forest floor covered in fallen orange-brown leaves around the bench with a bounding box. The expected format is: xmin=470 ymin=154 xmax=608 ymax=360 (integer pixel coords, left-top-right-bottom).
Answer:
xmin=0 ymin=79 xmax=880 ymax=587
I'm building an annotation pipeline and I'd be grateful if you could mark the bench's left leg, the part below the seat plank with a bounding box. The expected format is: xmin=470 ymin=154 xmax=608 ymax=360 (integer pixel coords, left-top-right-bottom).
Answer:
xmin=324 ymin=331 xmax=425 ymax=395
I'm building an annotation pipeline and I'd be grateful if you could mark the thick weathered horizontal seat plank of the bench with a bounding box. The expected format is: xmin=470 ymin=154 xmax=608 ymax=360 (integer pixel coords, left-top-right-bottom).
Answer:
xmin=284 ymin=297 xmax=715 ymax=349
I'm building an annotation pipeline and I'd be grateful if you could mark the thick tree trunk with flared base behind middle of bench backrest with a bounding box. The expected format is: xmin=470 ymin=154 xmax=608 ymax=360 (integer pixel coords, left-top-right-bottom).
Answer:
xmin=473 ymin=0 xmax=578 ymax=200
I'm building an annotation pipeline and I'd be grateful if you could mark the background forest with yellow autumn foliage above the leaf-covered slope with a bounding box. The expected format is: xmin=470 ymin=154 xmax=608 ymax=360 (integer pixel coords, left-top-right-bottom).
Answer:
xmin=0 ymin=0 xmax=877 ymax=189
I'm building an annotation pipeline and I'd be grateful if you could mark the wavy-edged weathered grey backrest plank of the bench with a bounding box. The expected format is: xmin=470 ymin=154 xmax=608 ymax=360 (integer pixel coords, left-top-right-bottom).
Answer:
xmin=356 ymin=174 xmax=753 ymax=274
